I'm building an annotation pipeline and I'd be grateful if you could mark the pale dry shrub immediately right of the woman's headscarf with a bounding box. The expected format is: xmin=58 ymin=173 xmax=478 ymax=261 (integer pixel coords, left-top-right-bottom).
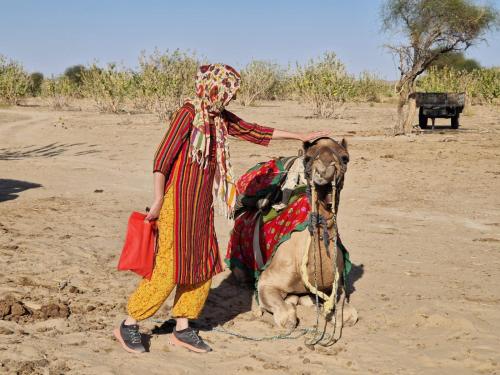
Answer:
xmin=238 ymin=60 xmax=285 ymax=105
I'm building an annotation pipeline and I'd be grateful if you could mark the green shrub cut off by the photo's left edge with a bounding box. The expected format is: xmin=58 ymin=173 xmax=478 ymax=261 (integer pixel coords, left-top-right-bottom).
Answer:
xmin=0 ymin=55 xmax=31 ymax=105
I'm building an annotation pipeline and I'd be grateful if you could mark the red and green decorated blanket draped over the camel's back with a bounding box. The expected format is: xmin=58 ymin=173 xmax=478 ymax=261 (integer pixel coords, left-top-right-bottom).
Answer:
xmin=225 ymin=158 xmax=351 ymax=279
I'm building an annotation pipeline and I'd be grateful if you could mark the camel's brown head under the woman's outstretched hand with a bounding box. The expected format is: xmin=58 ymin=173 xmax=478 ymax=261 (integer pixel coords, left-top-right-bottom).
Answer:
xmin=304 ymin=137 xmax=349 ymax=186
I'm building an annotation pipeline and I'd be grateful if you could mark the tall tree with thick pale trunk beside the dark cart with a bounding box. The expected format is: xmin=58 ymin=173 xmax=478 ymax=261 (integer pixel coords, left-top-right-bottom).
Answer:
xmin=382 ymin=0 xmax=499 ymax=135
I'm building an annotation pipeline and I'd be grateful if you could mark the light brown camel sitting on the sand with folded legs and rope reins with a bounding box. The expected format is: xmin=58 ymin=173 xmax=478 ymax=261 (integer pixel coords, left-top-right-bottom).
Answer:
xmin=252 ymin=138 xmax=357 ymax=328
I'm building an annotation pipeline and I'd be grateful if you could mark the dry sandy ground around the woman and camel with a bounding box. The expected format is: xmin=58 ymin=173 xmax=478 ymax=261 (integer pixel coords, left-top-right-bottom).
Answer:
xmin=0 ymin=102 xmax=500 ymax=374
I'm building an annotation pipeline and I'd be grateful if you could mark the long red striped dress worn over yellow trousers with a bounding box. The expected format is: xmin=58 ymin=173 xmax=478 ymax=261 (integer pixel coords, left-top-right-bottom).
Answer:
xmin=154 ymin=104 xmax=274 ymax=285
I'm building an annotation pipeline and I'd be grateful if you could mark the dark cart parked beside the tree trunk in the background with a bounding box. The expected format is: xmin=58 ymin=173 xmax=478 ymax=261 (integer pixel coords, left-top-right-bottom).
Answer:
xmin=415 ymin=92 xmax=465 ymax=129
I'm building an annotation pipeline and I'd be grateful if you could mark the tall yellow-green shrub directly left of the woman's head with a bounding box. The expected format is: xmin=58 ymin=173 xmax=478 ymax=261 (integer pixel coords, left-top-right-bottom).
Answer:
xmin=134 ymin=50 xmax=200 ymax=120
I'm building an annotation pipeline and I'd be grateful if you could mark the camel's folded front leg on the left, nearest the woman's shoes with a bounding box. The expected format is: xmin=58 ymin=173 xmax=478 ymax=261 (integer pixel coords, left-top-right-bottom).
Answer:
xmin=259 ymin=285 xmax=297 ymax=328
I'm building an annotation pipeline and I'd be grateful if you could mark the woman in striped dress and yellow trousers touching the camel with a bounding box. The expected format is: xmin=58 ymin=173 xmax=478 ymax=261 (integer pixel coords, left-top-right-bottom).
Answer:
xmin=115 ymin=64 xmax=326 ymax=353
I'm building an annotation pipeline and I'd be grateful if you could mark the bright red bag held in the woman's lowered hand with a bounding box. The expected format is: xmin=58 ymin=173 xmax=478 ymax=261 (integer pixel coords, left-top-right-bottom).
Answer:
xmin=118 ymin=212 xmax=156 ymax=280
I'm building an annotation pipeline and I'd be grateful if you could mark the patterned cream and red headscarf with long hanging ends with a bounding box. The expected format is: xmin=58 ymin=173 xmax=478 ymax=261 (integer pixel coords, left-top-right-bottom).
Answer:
xmin=190 ymin=64 xmax=240 ymax=217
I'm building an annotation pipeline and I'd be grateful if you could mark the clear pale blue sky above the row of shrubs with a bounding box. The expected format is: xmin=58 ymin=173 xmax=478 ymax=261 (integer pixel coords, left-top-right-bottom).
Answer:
xmin=0 ymin=0 xmax=500 ymax=79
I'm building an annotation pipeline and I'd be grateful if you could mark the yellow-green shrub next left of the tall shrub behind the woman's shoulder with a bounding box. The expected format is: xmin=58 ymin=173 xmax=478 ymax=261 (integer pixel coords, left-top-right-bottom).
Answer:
xmin=81 ymin=64 xmax=134 ymax=113
